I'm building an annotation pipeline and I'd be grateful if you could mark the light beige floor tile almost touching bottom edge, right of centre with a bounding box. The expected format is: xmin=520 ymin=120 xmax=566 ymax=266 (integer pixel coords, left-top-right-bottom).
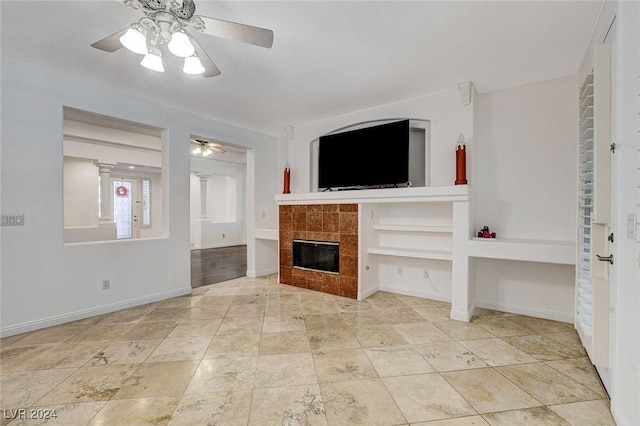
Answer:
xmin=382 ymin=373 xmax=477 ymax=423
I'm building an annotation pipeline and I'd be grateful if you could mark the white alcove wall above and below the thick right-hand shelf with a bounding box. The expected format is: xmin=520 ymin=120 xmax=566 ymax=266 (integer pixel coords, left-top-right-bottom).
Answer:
xmin=470 ymin=76 xmax=578 ymax=322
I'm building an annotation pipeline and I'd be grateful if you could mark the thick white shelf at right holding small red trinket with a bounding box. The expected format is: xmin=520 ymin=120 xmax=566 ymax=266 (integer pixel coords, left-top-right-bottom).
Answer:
xmin=467 ymin=238 xmax=576 ymax=265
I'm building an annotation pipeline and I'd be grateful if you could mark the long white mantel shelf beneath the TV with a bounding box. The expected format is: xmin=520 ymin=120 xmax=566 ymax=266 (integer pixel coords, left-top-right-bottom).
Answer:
xmin=275 ymin=185 xmax=469 ymax=205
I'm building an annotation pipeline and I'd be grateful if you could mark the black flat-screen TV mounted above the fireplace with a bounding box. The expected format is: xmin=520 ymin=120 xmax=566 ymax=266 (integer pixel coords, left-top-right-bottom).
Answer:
xmin=318 ymin=120 xmax=409 ymax=190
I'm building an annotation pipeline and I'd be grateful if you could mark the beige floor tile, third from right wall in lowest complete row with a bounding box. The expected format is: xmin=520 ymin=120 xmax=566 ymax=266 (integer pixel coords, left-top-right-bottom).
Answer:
xmin=440 ymin=368 xmax=542 ymax=414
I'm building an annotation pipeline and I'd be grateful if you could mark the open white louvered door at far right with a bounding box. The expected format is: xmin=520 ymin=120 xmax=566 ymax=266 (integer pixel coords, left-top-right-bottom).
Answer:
xmin=576 ymin=38 xmax=615 ymax=374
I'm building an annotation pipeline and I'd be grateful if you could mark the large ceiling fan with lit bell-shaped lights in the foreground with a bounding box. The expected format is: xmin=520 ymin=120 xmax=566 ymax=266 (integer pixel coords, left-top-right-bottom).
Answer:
xmin=91 ymin=0 xmax=273 ymax=77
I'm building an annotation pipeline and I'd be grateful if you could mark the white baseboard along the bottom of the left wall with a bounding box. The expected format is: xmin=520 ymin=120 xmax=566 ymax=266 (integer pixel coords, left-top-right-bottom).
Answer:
xmin=0 ymin=287 xmax=191 ymax=337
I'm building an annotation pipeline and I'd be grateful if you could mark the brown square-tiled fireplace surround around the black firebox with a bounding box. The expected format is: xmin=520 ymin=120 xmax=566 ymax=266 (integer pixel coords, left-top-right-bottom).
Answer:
xmin=279 ymin=204 xmax=358 ymax=299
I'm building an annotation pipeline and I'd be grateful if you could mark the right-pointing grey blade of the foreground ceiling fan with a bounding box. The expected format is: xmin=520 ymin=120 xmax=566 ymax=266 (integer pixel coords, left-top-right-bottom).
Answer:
xmin=192 ymin=16 xmax=273 ymax=49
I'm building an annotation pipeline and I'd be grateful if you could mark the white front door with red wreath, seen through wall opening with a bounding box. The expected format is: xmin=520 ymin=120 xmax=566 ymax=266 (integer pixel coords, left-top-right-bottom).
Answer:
xmin=112 ymin=179 xmax=139 ymax=239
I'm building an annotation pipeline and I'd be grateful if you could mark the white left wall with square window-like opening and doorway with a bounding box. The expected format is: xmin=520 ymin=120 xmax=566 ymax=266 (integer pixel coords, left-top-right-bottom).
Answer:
xmin=0 ymin=57 xmax=279 ymax=335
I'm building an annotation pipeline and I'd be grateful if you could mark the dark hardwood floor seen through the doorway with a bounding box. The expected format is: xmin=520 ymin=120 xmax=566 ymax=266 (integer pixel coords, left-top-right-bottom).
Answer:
xmin=191 ymin=245 xmax=247 ymax=288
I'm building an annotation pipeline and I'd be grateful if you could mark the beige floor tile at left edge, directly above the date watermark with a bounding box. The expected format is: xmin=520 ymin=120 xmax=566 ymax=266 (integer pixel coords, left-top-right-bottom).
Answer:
xmin=0 ymin=368 xmax=75 ymax=409
